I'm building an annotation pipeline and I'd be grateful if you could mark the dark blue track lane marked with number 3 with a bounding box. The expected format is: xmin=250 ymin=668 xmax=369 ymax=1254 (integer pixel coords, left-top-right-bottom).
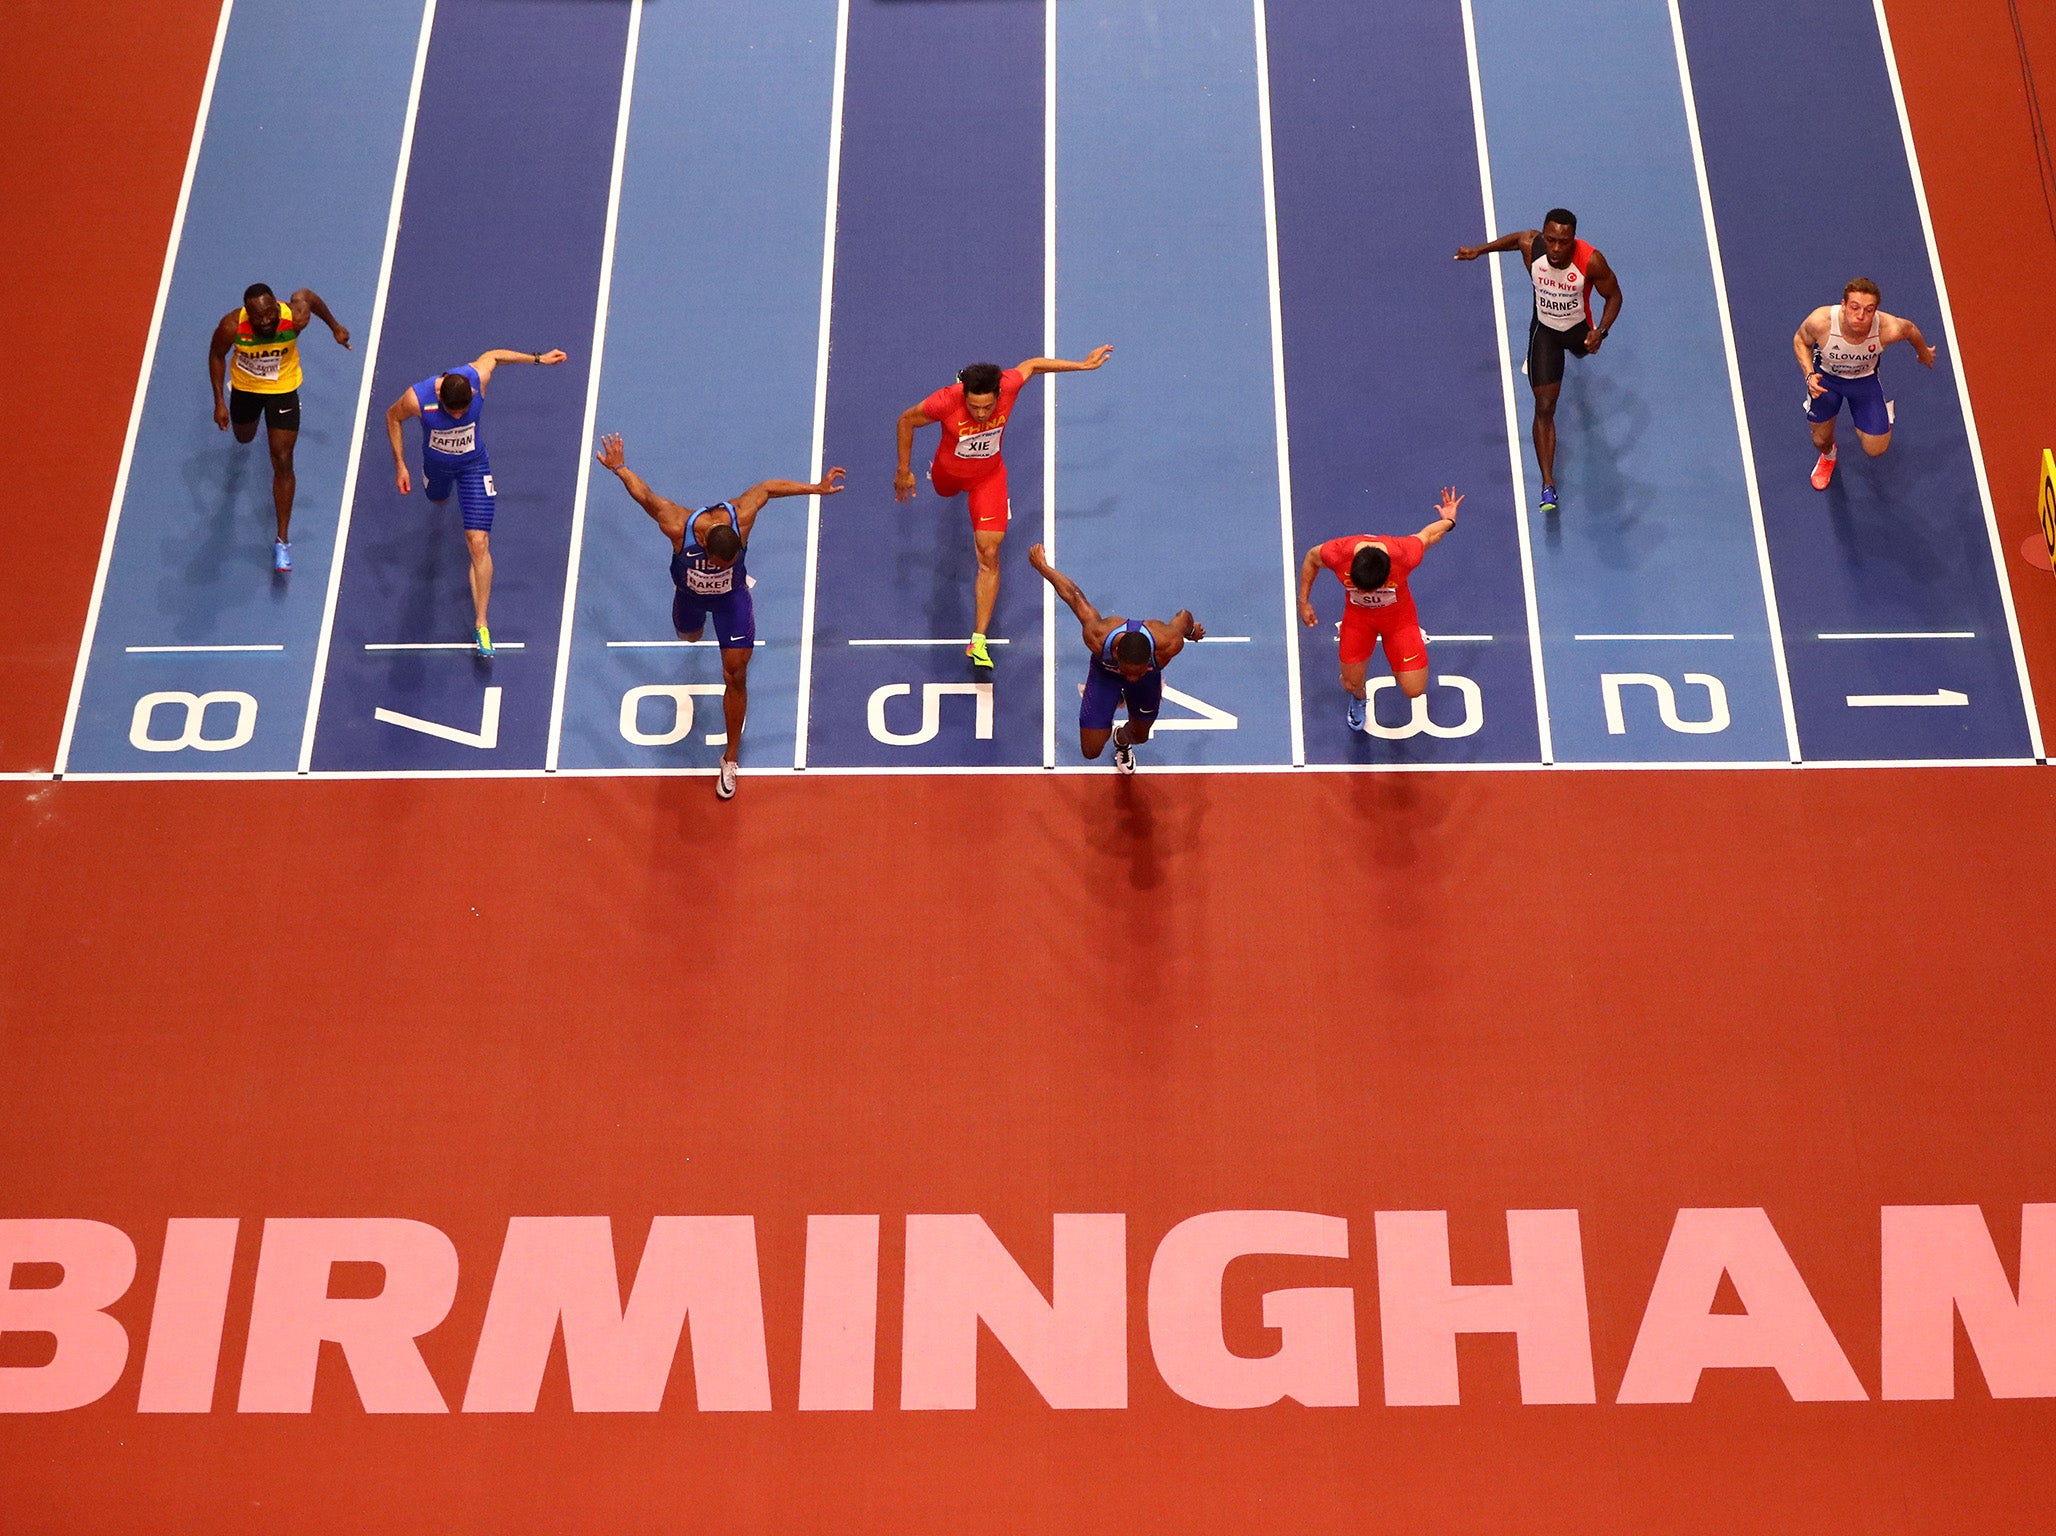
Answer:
xmin=1271 ymin=4 xmax=1540 ymax=763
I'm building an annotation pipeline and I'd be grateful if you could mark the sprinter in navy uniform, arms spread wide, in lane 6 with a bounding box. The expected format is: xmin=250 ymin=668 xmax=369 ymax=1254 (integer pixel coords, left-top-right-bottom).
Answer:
xmin=596 ymin=432 xmax=843 ymax=800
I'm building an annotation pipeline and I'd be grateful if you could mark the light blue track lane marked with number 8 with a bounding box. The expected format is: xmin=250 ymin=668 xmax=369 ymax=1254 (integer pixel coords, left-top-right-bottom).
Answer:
xmin=60 ymin=0 xmax=421 ymax=773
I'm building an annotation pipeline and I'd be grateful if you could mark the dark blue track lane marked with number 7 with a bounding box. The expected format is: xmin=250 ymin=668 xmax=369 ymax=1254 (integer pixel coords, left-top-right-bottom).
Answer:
xmin=315 ymin=0 xmax=629 ymax=771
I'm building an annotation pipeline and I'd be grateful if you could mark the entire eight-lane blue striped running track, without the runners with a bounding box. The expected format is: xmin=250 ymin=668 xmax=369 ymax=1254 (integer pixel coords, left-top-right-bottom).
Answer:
xmin=62 ymin=0 xmax=2042 ymax=775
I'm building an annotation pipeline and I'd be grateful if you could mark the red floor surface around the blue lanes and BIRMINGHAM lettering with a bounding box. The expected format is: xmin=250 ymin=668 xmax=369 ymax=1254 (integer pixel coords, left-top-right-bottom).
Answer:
xmin=0 ymin=0 xmax=2056 ymax=1536
